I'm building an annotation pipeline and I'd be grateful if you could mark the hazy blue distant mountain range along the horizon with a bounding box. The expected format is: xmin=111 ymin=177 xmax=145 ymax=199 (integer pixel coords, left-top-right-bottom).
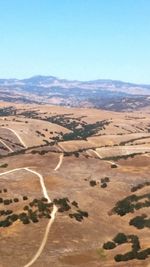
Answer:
xmin=0 ymin=75 xmax=150 ymax=110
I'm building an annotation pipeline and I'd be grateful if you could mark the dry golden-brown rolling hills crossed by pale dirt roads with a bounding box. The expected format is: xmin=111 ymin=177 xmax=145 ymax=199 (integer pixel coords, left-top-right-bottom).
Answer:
xmin=0 ymin=103 xmax=150 ymax=267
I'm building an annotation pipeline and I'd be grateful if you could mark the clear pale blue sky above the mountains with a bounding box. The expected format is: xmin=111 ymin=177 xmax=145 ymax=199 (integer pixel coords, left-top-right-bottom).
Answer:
xmin=0 ymin=0 xmax=150 ymax=84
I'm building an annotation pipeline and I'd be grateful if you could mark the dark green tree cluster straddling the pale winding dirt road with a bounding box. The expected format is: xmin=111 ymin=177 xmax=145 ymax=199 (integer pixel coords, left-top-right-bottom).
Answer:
xmin=0 ymin=188 xmax=88 ymax=227
